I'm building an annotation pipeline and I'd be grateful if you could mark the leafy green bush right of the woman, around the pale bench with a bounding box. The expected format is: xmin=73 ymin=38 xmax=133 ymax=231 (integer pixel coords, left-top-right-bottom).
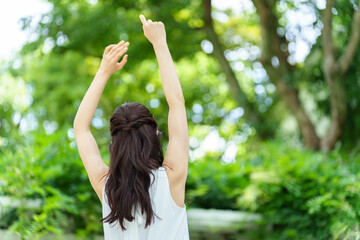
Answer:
xmin=187 ymin=142 xmax=360 ymax=240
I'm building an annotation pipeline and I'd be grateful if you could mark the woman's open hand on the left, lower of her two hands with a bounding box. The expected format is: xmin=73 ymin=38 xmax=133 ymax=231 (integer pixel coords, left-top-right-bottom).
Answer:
xmin=99 ymin=41 xmax=129 ymax=77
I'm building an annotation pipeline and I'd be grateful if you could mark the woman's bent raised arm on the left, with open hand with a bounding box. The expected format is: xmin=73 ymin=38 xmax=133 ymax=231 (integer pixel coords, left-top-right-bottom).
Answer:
xmin=74 ymin=41 xmax=129 ymax=201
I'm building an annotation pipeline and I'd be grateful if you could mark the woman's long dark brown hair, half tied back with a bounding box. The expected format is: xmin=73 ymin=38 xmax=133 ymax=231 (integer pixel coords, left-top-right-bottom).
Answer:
xmin=99 ymin=102 xmax=164 ymax=230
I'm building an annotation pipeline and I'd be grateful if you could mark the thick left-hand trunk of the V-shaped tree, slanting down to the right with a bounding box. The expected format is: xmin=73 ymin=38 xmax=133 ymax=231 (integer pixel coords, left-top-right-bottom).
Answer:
xmin=253 ymin=0 xmax=320 ymax=149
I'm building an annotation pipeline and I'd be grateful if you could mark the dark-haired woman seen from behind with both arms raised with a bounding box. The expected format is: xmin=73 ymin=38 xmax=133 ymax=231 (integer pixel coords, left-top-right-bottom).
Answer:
xmin=74 ymin=15 xmax=189 ymax=240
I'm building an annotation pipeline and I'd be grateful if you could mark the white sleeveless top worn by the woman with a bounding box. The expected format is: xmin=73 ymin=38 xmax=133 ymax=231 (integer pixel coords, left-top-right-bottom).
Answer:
xmin=102 ymin=167 xmax=190 ymax=240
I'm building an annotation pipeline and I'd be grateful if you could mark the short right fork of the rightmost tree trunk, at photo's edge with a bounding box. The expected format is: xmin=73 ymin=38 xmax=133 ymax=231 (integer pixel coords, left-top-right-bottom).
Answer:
xmin=338 ymin=1 xmax=360 ymax=75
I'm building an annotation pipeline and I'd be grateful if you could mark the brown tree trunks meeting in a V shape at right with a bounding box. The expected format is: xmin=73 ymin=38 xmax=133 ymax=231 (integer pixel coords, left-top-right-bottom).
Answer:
xmin=253 ymin=0 xmax=360 ymax=152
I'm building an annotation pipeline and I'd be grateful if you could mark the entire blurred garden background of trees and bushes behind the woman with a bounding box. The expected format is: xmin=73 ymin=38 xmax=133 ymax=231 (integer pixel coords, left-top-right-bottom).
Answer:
xmin=0 ymin=0 xmax=360 ymax=240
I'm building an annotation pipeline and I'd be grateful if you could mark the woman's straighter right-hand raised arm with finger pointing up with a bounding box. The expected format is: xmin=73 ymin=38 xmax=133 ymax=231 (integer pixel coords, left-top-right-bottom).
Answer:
xmin=140 ymin=15 xmax=189 ymax=206
